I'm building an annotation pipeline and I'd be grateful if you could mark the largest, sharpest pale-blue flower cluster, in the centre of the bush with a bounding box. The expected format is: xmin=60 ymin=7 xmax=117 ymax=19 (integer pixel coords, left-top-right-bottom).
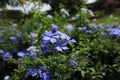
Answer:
xmin=41 ymin=25 xmax=76 ymax=53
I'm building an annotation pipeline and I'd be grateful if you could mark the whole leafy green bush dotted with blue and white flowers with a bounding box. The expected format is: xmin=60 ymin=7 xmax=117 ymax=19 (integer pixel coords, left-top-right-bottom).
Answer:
xmin=0 ymin=0 xmax=120 ymax=80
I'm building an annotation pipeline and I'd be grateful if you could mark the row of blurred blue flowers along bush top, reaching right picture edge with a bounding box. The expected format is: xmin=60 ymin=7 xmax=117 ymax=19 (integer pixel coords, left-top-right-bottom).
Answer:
xmin=78 ymin=24 xmax=120 ymax=37
